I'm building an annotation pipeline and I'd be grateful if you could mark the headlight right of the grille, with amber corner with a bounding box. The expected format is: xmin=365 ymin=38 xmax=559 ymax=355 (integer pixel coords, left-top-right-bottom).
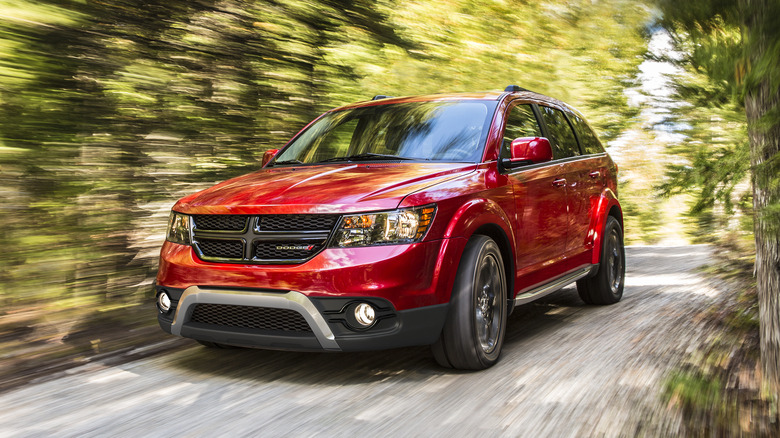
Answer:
xmin=331 ymin=205 xmax=436 ymax=248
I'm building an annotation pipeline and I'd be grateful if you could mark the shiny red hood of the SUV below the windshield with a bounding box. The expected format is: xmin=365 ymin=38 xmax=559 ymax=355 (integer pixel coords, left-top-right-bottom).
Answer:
xmin=174 ymin=163 xmax=476 ymax=214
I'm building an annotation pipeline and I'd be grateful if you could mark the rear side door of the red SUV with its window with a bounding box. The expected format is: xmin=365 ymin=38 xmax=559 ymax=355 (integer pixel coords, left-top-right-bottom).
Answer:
xmin=539 ymin=105 xmax=593 ymax=262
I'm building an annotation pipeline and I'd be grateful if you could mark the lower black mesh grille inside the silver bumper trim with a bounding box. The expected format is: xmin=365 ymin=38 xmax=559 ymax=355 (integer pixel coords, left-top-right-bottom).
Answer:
xmin=190 ymin=304 xmax=312 ymax=333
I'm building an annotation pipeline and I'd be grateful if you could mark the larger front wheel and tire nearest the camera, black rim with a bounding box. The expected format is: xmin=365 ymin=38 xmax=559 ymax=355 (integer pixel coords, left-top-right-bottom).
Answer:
xmin=432 ymin=235 xmax=507 ymax=370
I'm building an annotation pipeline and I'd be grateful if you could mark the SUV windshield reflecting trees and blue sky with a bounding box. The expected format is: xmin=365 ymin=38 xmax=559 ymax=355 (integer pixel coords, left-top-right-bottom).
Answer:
xmin=273 ymin=101 xmax=496 ymax=165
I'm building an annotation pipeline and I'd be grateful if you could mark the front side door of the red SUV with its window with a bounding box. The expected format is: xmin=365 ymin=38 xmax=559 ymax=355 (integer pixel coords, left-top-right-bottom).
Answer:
xmin=500 ymin=103 xmax=568 ymax=292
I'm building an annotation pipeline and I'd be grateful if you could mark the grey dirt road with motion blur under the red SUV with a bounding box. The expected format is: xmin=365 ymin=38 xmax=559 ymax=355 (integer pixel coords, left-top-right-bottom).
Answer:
xmin=0 ymin=246 xmax=719 ymax=437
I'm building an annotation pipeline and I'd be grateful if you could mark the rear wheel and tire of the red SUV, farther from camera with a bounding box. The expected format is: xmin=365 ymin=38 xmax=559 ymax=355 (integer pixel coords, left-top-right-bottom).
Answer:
xmin=577 ymin=216 xmax=626 ymax=304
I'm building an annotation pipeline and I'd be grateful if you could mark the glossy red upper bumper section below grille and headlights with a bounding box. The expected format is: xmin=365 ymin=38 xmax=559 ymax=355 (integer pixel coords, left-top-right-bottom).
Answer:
xmin=157 ymin=238 xmax=467 ymax=310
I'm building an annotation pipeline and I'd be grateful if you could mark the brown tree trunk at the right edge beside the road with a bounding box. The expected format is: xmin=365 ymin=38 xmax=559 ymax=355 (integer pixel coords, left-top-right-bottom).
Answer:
xmin=743 ymin=0 xmax=780 ymax=395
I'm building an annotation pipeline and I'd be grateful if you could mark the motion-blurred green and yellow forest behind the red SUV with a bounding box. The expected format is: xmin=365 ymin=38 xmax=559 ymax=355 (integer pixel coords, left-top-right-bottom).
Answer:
xmin=0 ymin=0 xmax=780 ymax=432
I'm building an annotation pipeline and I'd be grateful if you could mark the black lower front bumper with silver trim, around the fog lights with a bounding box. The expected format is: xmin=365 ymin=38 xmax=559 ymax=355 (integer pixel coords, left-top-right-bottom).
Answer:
xmin=157 ymin=286 xmax=448 ymax=351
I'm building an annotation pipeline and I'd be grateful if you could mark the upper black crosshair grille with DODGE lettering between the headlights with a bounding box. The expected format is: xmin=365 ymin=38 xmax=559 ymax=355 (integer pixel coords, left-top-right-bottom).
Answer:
xmin=193 ymin=214 xmax=340 ymax=264
